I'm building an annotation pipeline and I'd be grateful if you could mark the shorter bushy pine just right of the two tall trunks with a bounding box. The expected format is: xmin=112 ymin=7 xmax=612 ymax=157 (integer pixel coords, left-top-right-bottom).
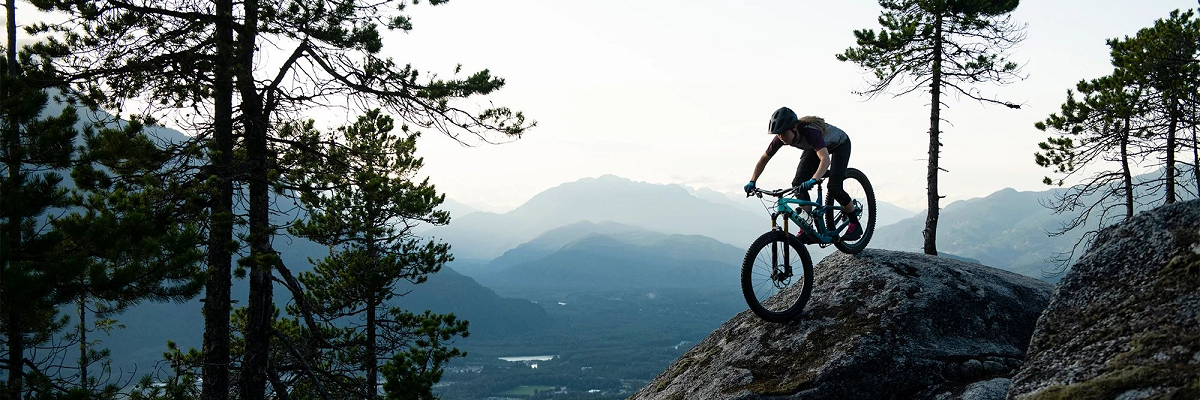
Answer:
xmin=286 ymin=109 xmax=467 ymax=398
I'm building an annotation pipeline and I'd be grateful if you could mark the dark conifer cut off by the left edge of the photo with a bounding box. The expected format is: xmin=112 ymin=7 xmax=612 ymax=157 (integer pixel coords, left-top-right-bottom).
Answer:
xmin=0 ymin=53 xmax=82 ymax=400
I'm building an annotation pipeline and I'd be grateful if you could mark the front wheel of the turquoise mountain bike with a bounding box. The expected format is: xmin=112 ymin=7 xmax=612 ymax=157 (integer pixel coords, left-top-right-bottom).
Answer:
xmin=742 ymin=231 xmax=812 ymax=322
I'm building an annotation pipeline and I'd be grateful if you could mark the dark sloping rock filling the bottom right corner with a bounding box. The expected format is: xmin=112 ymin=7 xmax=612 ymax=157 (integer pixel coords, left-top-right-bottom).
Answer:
xmin=1008 ymin=201 xmax=1200 ymax=400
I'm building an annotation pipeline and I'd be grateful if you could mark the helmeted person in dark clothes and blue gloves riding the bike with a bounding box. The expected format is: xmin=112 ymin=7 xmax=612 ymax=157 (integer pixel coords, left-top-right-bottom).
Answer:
xmin=744 ymin=107 xmax=863 ymax=240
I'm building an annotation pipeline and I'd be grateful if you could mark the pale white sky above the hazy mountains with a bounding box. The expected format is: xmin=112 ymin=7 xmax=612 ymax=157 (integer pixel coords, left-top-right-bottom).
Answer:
xmin=11 ymin=0 xmax=1196 ymax=211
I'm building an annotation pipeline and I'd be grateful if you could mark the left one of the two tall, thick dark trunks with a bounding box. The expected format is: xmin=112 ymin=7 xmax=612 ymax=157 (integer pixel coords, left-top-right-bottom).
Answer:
xmin=200 ymin=0 xmax=234 ymax=400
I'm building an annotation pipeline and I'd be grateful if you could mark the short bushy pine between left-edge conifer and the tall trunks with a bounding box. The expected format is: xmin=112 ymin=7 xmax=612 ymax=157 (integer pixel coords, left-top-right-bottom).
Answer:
xmin=54 ymin=121 xmax=204 ymax=393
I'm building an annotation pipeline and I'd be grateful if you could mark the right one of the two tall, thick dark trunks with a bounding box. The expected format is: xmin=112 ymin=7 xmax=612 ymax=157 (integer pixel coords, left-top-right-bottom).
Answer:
xmin=236 ymin=0 xmax=277 ymax=400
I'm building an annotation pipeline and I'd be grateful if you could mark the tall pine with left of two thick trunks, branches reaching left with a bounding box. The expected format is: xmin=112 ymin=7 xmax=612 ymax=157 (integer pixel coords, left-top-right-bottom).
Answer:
xmin=29 ymin=0 xmax=239 ymax=400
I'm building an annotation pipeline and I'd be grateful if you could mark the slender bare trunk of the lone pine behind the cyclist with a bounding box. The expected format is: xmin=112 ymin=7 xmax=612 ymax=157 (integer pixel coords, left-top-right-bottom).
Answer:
xmin=924 ymin=16 xmax=942 ymax=256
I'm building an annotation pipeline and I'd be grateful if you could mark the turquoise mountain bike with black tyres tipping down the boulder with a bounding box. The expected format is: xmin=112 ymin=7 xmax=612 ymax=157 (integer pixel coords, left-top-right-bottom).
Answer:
xmin=742 ymin=168 xmax=875 ymax=322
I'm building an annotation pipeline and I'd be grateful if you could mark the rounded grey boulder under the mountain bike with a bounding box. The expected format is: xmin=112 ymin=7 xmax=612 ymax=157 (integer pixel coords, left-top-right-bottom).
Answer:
xmin=630 ymin=249 xmax=1051 ymax=400
